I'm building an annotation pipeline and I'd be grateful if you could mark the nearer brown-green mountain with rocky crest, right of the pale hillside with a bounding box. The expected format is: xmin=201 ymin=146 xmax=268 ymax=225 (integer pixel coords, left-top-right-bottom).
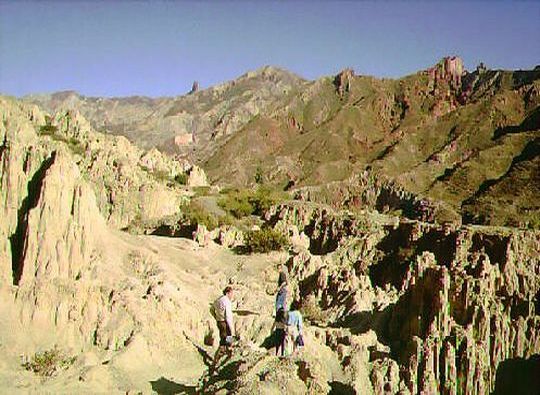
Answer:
xmin=204 ymin=58 xmax=540 ymax=226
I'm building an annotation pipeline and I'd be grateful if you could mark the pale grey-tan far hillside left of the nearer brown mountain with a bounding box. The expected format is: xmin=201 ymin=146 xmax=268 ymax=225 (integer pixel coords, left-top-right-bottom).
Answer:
xmin=25 ymin=67 xmax=304 ymax=160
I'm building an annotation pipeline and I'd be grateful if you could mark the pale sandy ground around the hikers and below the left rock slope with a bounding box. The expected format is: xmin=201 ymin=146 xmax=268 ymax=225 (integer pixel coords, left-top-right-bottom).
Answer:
xmin=0 ymin=232 xmax=286 ymax=394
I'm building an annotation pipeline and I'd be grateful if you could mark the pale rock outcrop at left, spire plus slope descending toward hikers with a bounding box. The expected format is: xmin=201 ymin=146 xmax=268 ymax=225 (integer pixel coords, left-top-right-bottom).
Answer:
xmin=0 ymin=98 xmax=214 ymax=392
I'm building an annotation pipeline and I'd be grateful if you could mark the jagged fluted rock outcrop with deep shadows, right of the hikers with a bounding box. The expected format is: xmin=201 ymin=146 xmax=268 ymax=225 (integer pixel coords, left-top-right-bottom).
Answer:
xmin=264 ymin=206 xmax=540 ymax=393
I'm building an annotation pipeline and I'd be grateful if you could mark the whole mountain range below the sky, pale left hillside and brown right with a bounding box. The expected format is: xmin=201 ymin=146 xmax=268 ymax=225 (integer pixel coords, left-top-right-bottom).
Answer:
xmin=28 ymin=58 xmax=540 ymax=227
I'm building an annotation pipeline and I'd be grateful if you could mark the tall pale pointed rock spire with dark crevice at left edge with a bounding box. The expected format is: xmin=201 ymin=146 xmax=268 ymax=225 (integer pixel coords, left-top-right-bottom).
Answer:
xmin=0 ymin=100 xmax=104 ymax=286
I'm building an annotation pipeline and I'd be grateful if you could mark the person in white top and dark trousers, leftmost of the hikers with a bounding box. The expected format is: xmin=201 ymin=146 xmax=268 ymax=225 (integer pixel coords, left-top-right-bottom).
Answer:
xmin=212 ymin=286 xmax=235 ymax=365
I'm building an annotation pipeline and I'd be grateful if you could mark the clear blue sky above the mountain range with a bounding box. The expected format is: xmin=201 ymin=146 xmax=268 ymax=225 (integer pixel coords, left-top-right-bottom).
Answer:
xmin=0 ymin=0 xmax=540 ymax=97
